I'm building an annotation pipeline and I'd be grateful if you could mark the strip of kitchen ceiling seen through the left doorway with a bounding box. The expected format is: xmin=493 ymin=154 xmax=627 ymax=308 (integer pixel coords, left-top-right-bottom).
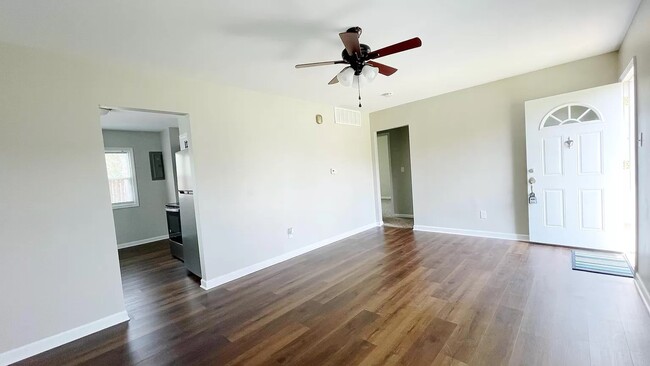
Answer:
xmin=99 ymin=109 xmax=178 ymax=132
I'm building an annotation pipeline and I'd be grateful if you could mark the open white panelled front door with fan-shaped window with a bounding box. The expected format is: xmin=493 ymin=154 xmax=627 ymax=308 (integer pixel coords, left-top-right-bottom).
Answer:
xmin=526 ymin=83 xmax=626 ymax=250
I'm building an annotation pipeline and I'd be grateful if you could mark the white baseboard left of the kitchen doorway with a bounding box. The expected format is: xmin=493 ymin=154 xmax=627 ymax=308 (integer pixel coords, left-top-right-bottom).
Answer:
xmin=0 ymin=311 xmax=129 ymax=365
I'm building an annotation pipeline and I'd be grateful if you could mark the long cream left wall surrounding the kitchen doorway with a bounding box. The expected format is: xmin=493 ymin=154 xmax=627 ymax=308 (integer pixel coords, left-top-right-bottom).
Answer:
xmin=0 ymin=41 xmax=376 ymax=353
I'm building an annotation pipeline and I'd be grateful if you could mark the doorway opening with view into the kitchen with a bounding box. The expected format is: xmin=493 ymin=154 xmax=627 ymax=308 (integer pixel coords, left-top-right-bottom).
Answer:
xmin=99 ymin=106 xmax=202 ymax=284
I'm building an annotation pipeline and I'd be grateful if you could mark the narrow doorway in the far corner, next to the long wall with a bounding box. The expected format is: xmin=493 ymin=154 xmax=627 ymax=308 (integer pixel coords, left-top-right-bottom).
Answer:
xmin=377 ymin=126 xmax=414 ymax=229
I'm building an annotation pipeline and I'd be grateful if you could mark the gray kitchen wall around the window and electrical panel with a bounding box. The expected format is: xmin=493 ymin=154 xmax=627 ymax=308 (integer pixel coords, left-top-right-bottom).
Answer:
xmin=102 ymin=130 xmax=170 ymax=245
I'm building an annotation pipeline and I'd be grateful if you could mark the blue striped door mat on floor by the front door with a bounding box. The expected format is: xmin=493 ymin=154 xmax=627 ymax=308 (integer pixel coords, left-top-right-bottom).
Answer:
xmin=571 ymin=250 xmax=634 ymax=277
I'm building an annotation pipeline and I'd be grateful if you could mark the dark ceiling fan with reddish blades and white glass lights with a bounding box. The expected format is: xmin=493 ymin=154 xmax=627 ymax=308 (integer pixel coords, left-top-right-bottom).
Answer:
xmin=296 ymin=27 xmax=422 ymax=107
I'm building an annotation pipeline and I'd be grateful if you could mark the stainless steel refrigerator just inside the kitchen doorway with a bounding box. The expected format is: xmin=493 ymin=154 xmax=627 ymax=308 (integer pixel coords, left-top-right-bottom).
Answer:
xmin=176 ymin=149 xmax=201 ymax=277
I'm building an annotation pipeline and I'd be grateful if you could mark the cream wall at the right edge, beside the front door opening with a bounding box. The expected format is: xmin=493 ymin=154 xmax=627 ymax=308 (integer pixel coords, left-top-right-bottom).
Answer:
xmin=619 ymin=0 xmax=650 ymax=287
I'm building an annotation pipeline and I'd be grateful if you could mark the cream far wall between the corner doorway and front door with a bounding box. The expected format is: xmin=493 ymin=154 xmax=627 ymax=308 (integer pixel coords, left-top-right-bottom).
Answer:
xmin=370 ymin=53 xmax=618 ymax=235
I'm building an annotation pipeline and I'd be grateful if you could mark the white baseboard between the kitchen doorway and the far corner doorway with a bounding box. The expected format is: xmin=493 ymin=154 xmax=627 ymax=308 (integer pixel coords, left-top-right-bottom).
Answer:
xmin=201 ymin=223 xmax=381 ymax=290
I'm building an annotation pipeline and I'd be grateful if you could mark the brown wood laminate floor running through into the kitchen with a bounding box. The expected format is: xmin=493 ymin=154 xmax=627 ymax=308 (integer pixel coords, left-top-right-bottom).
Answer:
xmin=15 ymin=228 xmax=650 ymax=366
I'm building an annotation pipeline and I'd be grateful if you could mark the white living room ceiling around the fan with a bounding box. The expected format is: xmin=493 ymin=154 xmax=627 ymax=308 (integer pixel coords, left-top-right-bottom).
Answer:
xmin=0 ymin=0 xmax=640 ymax=111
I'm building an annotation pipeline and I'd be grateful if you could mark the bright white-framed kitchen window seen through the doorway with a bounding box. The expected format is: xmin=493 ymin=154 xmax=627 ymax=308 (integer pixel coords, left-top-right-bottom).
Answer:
xmin=104 ymin=147 xmax=139 ymax=209
